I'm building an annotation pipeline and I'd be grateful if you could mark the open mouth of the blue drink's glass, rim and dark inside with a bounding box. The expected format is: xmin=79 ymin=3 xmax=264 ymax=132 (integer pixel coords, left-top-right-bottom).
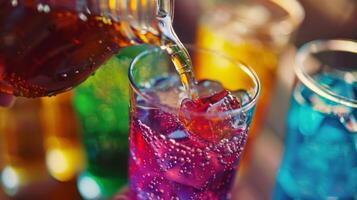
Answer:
xmin=295 ymin=40 xmax=357 ymax=108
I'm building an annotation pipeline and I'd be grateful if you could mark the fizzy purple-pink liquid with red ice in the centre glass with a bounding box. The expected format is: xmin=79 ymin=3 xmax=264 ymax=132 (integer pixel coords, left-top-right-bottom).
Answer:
xmin=129 ymin=90 xmax=251 ymax=200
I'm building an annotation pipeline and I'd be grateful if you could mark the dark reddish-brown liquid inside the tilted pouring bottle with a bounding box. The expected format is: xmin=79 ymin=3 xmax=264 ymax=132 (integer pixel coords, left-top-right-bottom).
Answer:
xmin=0 ymin=0 xmax=160 ymax=97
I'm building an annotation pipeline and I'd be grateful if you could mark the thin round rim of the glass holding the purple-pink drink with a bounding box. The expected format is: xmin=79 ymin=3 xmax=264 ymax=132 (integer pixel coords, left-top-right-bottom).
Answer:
xmin=128 ymin=44 xmax=261 ymax=117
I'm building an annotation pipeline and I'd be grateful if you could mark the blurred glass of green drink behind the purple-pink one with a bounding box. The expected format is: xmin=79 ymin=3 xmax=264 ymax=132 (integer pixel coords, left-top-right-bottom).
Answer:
xmin=74 ymin=46 xmax=145 ymax=199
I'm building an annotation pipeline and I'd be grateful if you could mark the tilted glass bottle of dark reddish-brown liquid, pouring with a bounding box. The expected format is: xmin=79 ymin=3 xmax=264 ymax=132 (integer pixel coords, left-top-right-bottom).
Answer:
xmin=0 ymin=0 xmax=181 ymax=97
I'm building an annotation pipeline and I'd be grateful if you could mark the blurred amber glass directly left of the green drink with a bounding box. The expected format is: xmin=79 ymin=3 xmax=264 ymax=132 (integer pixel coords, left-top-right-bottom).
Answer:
xmin=41 ymin=92 xmax=84 ymax=181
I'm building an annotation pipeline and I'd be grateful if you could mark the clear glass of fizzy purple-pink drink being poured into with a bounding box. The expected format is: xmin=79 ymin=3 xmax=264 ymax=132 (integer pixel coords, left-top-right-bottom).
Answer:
xmin=129 ymin=45 xmax=260 ymax=199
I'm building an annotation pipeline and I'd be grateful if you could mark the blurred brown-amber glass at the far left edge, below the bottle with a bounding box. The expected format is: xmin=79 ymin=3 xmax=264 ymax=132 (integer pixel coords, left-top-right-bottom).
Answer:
xmin=0 ymin=98 xmax=48 ymax=196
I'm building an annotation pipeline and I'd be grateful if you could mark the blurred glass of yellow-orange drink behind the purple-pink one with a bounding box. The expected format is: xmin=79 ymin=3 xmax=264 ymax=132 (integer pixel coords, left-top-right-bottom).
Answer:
xmin=195 ymin=0 xmax=304 ymax=171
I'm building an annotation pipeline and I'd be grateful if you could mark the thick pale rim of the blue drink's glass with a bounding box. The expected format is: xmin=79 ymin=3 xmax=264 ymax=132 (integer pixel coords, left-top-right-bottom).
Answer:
xmin=295 ymin=39 xmax=357 ymax=108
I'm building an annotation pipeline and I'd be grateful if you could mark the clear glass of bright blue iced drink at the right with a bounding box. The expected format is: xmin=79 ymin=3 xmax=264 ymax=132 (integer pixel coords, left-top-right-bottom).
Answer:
xmin=273 ymin=40 xmax=357 ymax=199
